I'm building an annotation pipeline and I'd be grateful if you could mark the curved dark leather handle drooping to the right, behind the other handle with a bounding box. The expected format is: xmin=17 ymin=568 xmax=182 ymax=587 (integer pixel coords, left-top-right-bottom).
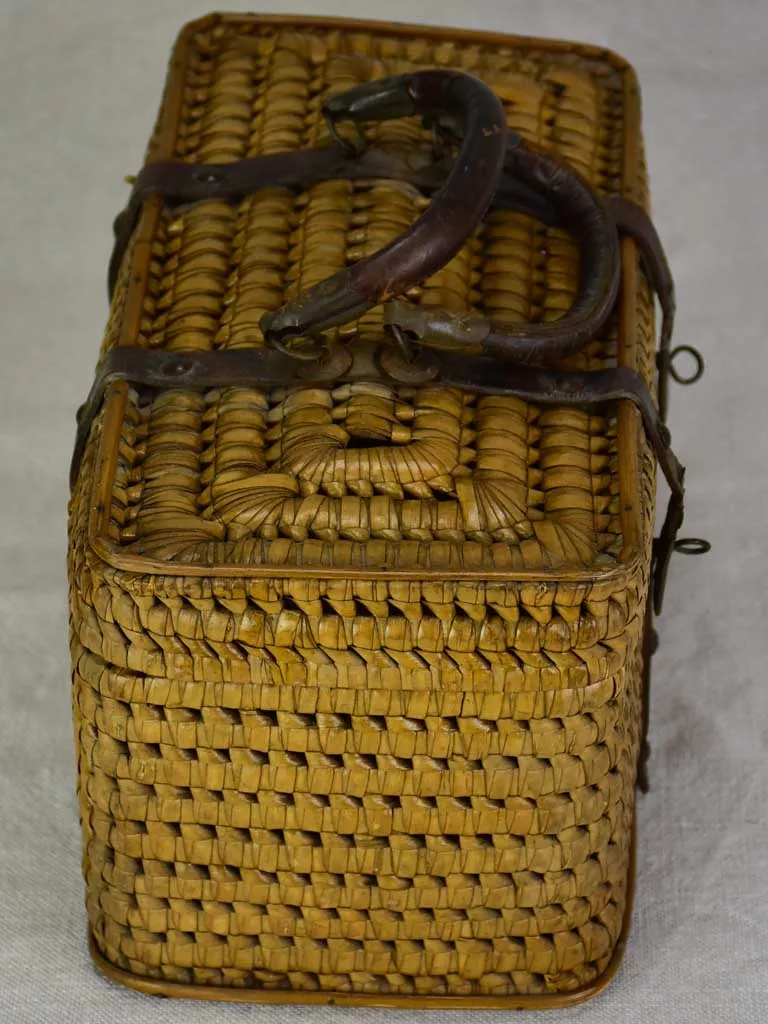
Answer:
xmin=385 ymin=144 xmax=621 ymax=364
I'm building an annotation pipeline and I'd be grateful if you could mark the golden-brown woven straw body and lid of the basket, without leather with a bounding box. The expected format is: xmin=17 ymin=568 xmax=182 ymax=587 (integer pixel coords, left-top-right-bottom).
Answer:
xmin=70 ymin=15 xmax=655 ymax=1008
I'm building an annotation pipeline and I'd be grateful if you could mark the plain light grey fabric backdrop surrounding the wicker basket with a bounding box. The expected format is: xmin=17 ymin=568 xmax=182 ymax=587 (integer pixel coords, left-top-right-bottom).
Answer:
xmin=0 ymin=0 xmax=768 ymax=1024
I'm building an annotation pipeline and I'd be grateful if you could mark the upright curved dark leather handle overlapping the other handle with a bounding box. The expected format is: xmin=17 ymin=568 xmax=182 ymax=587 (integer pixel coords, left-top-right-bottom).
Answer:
xmin=261 ymin=71 xmax=509 ymax=346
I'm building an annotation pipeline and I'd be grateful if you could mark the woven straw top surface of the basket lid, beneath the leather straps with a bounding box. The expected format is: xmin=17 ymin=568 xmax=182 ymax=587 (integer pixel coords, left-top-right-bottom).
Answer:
xmin=88 ymin=16 xmax=652 ymax=577
